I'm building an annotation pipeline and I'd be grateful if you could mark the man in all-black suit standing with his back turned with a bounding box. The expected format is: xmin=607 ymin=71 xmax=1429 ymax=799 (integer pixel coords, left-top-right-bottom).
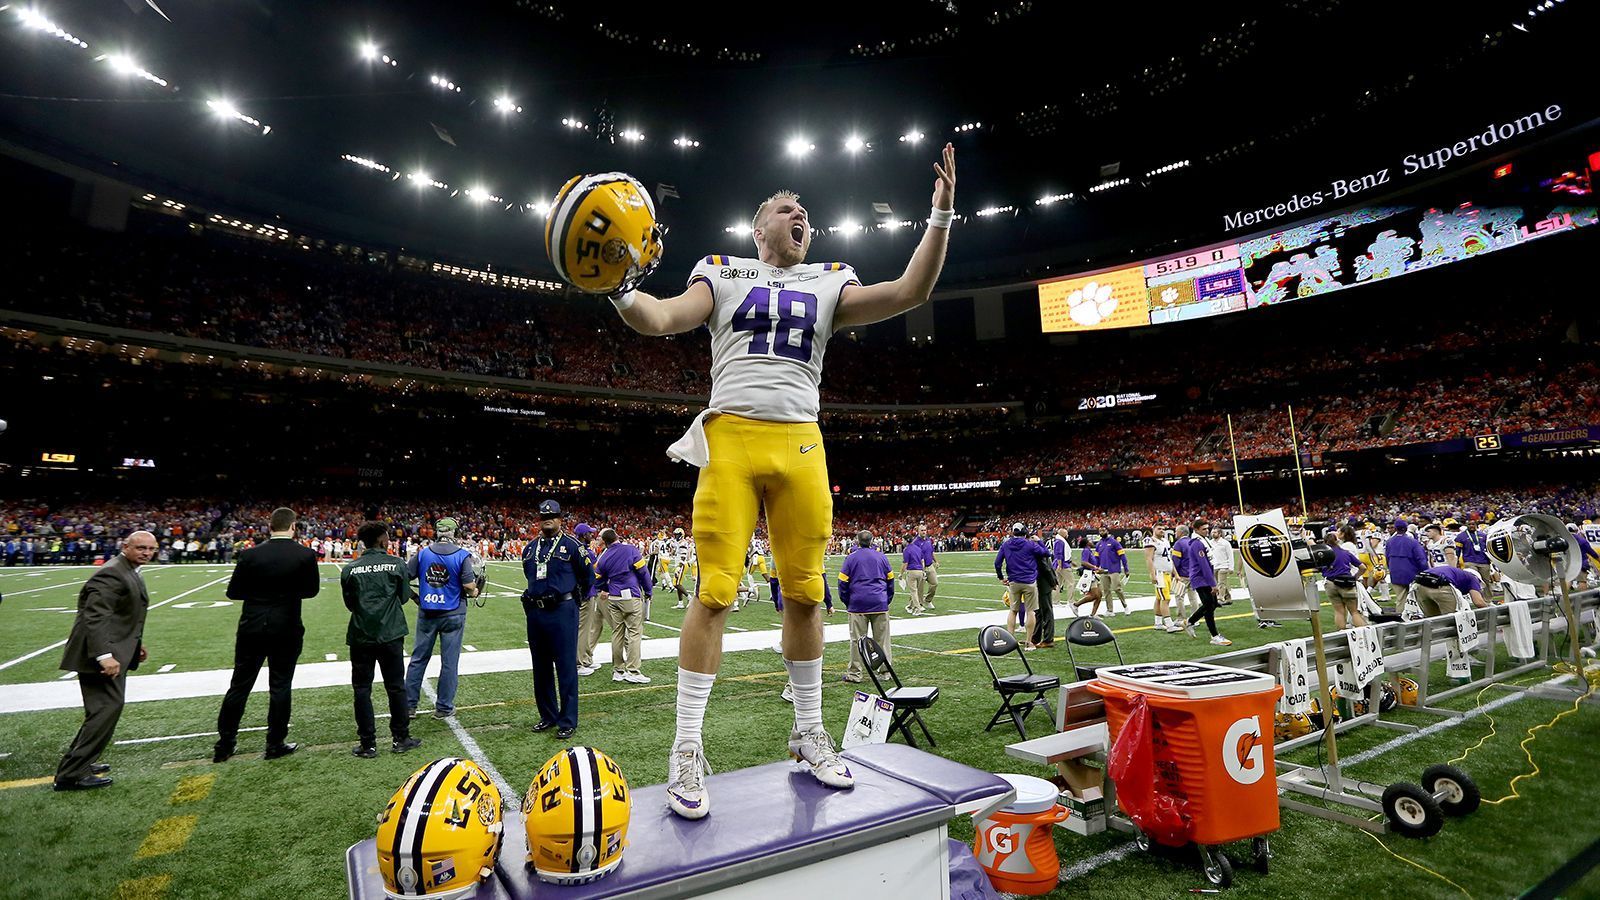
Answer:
xmin=211 ymin=506 xmax=322 ymax=762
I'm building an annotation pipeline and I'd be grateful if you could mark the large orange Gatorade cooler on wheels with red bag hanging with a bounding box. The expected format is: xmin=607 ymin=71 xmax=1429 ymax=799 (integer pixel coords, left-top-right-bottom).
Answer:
xmin=1088 ymin=661 xmax=1283 ymax=846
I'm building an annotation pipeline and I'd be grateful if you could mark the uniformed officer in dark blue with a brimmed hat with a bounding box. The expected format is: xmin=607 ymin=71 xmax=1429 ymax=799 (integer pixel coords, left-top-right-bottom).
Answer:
xmin=522 ymin=500 xmax=592 ymax=740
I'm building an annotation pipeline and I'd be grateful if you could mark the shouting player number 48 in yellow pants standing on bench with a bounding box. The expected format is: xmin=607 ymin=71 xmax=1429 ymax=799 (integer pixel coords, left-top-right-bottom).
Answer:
xmin=601 ymin=144 xmax=955 ymax=818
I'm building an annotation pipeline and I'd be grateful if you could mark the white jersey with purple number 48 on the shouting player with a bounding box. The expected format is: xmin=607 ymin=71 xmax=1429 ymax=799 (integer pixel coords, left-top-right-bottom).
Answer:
xmin=690 ymin=256 xmax=861 ymax=421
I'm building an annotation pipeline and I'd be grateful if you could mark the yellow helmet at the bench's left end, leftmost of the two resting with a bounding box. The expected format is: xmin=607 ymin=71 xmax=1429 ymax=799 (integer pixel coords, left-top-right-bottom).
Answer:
xmin=378 ymin=757 xmax=504 ymax=900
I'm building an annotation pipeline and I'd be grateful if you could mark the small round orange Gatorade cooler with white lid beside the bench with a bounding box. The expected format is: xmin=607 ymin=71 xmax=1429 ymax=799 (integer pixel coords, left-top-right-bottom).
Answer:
xmin=973 ymin=775 xmax=1067 ymax=897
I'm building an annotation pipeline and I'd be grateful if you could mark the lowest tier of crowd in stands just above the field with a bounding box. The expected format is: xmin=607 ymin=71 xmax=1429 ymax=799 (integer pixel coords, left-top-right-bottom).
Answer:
xmin=0 ymin=482 xmax=1600 ymax=565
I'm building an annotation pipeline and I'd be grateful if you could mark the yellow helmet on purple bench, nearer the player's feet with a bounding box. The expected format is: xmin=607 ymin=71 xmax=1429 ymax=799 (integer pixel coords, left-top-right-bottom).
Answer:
xmin=522 ymin=746 xmax=634 ymax=884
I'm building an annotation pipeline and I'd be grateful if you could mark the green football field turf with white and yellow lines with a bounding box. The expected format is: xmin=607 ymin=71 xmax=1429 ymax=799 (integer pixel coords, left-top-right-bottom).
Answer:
xmin=0 ymin=554 xmax=1600 ymax=898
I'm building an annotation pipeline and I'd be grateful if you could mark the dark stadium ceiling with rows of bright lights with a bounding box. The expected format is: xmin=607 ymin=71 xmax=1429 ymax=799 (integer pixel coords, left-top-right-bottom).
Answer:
xmin=0 ymin=0 xmax=1595 ymax=282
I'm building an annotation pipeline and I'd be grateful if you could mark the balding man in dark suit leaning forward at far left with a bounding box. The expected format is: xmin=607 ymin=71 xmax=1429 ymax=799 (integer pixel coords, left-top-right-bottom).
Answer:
xmin=56 ymin=532 xmax=155 ymax=791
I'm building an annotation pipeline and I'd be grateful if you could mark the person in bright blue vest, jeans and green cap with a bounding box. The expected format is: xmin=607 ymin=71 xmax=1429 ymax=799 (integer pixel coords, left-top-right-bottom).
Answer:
xmin=405 ymin=517 xmax=485 ymax=719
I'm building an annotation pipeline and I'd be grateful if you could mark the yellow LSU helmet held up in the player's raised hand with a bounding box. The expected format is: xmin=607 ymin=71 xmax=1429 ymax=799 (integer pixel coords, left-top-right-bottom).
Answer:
xmin=544 ymin=171 xmax=667 ymax=295
